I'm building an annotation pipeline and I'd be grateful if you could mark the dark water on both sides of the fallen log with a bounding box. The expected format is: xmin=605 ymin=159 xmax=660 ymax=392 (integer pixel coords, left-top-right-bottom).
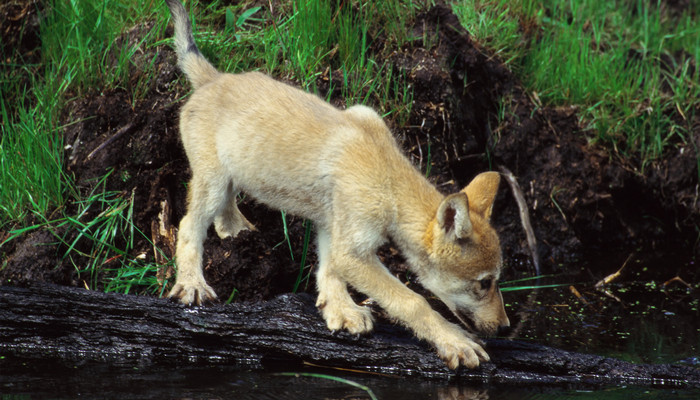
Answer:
xmin=0 ymin=255 xmax=700 ymax=400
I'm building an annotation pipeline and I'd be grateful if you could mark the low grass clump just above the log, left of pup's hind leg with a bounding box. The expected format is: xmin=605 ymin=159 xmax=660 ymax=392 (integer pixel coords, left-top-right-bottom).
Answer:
xmin=0 ymin=172 xmax=172 ymax=295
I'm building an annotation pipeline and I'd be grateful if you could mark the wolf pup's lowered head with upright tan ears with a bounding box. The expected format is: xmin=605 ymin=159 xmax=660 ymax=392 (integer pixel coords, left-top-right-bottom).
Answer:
xmin=419 ymin=172 xmax=510 ymax=335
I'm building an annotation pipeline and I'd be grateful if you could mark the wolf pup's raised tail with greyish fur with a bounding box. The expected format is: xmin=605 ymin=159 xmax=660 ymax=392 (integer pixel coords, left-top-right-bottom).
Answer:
xmin=165 ymin=0 xmax=219 ymax=89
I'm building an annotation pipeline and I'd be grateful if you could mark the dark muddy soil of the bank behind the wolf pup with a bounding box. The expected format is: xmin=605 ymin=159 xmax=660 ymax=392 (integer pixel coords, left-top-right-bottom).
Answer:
xmin=0 ymin=2 xmax=700 ymax=300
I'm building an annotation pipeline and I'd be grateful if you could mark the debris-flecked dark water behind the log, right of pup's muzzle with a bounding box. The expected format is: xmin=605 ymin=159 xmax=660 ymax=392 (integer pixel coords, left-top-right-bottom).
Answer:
xmin=503 ymin=259 xmax=700 ymax=363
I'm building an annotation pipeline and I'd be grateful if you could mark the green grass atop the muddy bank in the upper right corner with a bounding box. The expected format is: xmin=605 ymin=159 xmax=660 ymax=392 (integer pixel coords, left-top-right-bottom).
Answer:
xmin=454 ymin=0 xmax=700 ymax=170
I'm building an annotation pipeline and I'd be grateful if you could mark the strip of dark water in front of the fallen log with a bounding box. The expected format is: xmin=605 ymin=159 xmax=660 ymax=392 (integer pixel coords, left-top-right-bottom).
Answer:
xmin=0 ymin=357 xmax=697 ymax=400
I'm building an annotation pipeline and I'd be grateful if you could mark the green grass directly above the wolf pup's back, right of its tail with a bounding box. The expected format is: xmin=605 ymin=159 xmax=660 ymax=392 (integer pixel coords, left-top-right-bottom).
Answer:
xmin=190 ymin=0 xmax=418 ymax=124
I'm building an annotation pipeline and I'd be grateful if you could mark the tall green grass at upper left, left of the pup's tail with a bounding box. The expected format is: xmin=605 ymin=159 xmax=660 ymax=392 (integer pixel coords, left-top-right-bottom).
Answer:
xmin=0 ymin=0 xmax=165 ymax=229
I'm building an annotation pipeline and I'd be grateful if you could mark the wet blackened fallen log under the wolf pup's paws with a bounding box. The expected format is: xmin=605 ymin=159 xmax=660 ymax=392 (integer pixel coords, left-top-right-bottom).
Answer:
xmin=0 ymin=286 xmax=700 ymax=388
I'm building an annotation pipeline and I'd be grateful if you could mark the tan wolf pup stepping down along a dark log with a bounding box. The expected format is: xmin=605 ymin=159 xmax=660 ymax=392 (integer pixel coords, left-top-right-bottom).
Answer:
xmin=166 ymin=0 xmax=509 ymax=369
